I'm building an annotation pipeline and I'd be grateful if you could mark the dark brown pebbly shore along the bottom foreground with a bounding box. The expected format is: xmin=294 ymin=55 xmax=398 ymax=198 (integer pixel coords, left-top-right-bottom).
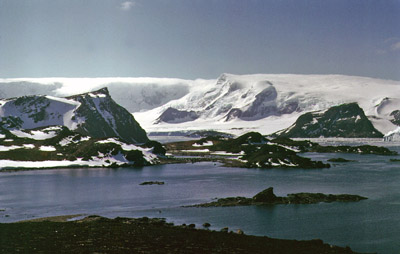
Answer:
xmin=0 ymin=215 xmax=362 ymax=254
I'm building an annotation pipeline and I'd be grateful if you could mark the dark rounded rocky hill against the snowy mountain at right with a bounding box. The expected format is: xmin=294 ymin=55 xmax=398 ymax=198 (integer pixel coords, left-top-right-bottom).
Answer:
xmin=275 ymin=103 xmax=383 ymax=138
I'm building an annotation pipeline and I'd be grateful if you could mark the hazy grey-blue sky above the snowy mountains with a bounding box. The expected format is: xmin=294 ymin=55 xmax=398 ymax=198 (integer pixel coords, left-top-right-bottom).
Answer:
xmin=0 ymin=0 xmax=400 ymax=80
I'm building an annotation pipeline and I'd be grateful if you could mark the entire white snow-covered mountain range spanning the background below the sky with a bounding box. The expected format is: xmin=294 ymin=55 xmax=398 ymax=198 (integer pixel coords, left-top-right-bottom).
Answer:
xmin=0 ymin=74 xmax=400 ymax=138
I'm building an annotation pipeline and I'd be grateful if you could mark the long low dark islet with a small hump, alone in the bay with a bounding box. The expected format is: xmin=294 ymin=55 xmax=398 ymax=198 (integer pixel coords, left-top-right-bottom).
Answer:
xmin=186 ymin=187 xmax=367 ymax=207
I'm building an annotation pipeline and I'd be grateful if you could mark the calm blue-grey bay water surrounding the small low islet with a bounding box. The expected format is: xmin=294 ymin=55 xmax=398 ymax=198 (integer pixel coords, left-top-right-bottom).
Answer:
xmin=0 ymin=143 xmax=400 ymax=254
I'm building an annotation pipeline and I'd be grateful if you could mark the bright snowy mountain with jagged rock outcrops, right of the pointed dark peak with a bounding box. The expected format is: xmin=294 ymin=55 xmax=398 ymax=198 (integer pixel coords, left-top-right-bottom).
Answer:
xmin=134 ymin=74 xmax=400 ymax=134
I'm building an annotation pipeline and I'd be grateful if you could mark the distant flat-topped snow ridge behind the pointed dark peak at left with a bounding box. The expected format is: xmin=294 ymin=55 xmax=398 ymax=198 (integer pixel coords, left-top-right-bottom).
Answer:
xmin=0 ymin=78 xmax=198 ymax=112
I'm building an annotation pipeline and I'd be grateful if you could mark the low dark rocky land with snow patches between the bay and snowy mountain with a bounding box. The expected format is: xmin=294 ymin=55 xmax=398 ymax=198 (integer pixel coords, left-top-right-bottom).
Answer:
xmin=165 ymin=132 xmax=397 ymax=169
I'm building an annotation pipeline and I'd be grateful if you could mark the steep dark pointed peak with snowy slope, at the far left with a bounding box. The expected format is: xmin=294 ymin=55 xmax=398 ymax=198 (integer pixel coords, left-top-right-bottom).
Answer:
xmin=0 ymin=88 xmax=149 ymax=143
